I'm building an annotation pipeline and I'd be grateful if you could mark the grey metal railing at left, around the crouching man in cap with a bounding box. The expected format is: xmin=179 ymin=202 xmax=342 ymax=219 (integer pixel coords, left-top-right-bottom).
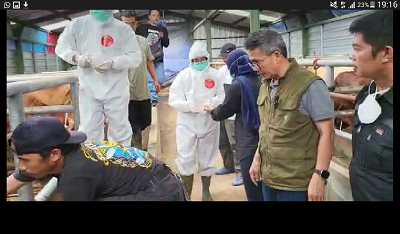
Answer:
xmin=7 ymin=71 xmax=80 ymax=201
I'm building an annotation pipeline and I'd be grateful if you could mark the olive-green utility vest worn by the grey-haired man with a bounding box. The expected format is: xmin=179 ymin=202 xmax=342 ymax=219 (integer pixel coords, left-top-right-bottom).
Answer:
xmin=257 ymin=59 xmax=321 ymax=191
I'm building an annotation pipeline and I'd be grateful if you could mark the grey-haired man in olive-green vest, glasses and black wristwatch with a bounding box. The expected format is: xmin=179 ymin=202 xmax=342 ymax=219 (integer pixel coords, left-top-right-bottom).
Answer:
xmin=245 ymin=29 xmax=335 ymax=201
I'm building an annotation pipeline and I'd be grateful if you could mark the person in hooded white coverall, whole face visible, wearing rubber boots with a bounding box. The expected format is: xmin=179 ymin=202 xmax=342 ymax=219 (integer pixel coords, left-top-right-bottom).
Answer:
xmin=169 ymin=41 xmax=225 ymax=201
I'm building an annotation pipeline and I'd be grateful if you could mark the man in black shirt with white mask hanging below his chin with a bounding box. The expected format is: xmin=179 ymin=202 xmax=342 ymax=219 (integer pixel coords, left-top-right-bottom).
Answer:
xmin=350 ymin=11 xmax=393 ymax=201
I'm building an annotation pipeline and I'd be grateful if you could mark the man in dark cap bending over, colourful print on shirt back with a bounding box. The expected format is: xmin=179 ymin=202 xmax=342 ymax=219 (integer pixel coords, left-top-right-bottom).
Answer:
xmin=7 ymin=117 xmax=187 ymax=201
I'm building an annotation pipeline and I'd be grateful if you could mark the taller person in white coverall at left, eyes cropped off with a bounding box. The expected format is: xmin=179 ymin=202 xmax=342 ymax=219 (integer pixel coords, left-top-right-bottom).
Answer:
xmin=55 ymin=10 xmax=142 ymax=146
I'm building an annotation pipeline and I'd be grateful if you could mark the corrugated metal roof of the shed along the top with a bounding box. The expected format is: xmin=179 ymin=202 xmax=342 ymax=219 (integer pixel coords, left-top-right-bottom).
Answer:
xmin=7 ymin=10 xmax=360 ymax=32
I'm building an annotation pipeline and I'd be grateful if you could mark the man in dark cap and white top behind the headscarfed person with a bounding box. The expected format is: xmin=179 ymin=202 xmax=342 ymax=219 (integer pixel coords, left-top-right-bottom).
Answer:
xmin=216 ymin=43 xmax=243 ymax=186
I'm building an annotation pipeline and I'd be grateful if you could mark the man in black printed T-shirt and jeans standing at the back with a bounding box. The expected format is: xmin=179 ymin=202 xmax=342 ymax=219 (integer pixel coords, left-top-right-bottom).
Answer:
xmin=135 ymin=10 xmax=169 ymax=106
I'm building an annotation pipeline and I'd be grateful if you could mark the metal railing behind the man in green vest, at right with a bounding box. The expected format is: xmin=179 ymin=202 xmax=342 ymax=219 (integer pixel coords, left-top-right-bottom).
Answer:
xmin=297 ymin=59 xmax=354 ymax=140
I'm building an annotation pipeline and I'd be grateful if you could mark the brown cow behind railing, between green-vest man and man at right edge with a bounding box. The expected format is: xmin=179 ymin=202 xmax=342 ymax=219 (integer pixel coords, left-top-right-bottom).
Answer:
xmin=332 ymin=71 xmax=371 ymax=133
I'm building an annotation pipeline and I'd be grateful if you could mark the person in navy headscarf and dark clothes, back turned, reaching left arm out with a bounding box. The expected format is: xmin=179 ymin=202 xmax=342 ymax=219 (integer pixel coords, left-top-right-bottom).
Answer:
xmin=208 ymin=49 xmax=263 ymax=201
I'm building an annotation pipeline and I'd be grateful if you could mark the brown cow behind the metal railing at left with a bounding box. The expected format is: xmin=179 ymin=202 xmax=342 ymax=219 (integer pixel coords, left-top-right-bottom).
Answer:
xmin=7 ymin=85 xmax=74 ymax=133
